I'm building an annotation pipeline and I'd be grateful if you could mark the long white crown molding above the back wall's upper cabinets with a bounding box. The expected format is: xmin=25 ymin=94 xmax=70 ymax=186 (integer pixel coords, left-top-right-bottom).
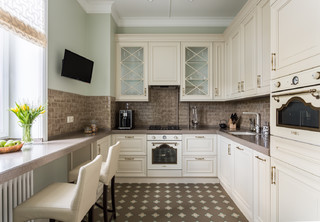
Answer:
xmin=112 ymin=14 xmax=233 ymax=27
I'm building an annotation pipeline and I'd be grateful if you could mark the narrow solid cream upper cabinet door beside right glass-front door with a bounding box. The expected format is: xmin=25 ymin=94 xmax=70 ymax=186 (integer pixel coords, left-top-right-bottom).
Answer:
xmin=213 ymin=42 xmax=225 ymax=100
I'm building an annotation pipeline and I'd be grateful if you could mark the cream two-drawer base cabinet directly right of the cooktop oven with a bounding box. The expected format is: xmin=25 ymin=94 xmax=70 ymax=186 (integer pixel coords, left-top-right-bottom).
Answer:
xmin=182 ymin=134 xmax=217 ymax=177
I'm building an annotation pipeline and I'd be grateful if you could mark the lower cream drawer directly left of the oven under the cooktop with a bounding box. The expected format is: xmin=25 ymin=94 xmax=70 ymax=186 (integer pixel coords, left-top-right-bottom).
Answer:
xmin=116 ymin=156 xmax=147 ymax=177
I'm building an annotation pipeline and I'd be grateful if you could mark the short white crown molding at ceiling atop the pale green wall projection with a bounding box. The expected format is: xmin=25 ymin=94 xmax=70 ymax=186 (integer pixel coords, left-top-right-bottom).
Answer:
xmin=77 ymin=0 xmax=114 ymax=13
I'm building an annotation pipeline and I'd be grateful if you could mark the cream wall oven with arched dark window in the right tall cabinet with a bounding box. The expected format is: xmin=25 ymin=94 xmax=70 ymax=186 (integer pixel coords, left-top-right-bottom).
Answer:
xmin=270 ymin=68 xmax=320 ymax=145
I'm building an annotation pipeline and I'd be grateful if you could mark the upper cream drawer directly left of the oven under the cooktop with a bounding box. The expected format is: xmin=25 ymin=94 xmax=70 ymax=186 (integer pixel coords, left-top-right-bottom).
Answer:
xmin=112 ymin=134 xmax=146 ymax=155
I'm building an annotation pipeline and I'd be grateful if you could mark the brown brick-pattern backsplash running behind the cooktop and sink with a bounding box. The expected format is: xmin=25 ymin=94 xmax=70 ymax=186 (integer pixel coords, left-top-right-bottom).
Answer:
xmin=116 ymin=88 xmax=270 ymax=128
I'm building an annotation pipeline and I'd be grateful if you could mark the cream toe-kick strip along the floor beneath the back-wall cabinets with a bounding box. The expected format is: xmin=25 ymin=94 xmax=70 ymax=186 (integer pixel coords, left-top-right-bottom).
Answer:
xmin=115 ymin=177 xmax=220 ymax=183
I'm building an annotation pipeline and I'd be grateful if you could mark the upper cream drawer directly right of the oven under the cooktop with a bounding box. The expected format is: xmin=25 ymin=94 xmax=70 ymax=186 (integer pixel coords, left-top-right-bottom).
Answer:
xmin=183 ymin=134 xmax=216 ymax=155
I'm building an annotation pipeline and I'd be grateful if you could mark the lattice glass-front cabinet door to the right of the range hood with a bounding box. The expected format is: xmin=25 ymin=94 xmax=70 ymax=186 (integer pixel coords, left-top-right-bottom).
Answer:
xmin=180 ymin=42 xmax=213 ymax=101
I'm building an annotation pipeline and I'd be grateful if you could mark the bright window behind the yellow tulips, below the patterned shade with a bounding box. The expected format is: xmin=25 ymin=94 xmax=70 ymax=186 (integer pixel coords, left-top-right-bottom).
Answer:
xmin=0 ymin=29 xmax=46 ymax=138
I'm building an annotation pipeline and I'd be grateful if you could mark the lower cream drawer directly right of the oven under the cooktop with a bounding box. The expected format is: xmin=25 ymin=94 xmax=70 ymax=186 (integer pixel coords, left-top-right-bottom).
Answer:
xmin=182 ymin=156 xmax=217 ymax=177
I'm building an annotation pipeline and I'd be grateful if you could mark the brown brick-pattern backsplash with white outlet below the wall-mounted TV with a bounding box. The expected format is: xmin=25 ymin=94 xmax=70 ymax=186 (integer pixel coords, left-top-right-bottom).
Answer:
xmin=48 ymin=89 xmax=115 ymax=137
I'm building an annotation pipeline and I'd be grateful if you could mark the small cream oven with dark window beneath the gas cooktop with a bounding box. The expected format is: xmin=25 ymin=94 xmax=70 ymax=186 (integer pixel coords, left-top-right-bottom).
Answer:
xmin=147 ymin=134 xmax=182 ymax=170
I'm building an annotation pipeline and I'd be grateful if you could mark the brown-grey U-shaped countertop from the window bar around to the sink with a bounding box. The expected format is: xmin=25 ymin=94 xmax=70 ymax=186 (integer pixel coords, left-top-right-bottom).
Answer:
xmin=0 ymin=126 xmax=270 ymax=184
